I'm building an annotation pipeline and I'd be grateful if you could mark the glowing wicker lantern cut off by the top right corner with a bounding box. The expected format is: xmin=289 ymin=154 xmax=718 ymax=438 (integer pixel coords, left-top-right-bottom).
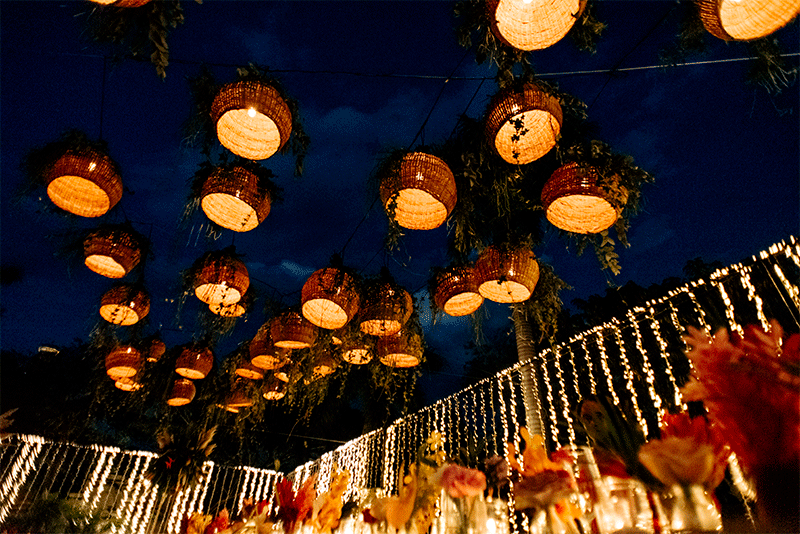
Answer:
xmin=697 ymin=0 xmax=800 ymax=41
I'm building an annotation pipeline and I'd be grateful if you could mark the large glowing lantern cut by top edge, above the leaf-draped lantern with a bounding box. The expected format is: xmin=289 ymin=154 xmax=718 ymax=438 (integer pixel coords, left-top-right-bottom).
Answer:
xmin=486 ymin=0 xmax=585 ymax=51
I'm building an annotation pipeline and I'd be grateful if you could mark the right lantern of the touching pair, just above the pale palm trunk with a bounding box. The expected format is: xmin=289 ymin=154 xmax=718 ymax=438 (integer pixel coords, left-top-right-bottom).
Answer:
xmin=475 ymin=246 xmax=539 ymax=304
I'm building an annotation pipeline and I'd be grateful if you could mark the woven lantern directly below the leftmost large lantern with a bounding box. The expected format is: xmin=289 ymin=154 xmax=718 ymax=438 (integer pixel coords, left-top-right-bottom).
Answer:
xmin=83 ymin=228 xmax=142 ymax=278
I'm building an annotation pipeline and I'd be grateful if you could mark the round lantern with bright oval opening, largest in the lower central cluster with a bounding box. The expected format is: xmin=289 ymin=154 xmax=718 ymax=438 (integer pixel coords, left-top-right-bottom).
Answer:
xmin=300 ymin=267 xmax=359 ymax=330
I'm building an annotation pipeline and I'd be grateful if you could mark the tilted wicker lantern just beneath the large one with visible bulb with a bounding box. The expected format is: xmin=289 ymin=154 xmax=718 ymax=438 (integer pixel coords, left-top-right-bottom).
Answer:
xmin=200 ymin=166 xmax=272 ymax=232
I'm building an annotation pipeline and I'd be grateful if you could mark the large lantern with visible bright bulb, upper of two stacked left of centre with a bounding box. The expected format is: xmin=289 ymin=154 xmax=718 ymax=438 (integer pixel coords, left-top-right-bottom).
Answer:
xmin=211 ymin=81 xmax=292 ymax=160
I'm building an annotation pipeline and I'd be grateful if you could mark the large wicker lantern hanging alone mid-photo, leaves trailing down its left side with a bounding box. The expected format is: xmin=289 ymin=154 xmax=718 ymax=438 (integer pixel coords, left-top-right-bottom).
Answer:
xmin=381 ymin=152 xmax=456 ymax=230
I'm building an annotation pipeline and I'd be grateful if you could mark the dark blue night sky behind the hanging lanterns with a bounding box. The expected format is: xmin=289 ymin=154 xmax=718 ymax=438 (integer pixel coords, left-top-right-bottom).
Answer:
xmin=0 ymin=0 xmax=800 ymax=402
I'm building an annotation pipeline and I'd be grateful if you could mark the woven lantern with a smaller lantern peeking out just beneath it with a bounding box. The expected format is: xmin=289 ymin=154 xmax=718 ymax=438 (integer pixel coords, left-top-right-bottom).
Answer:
xmin=194 ymin=251 xmax=250 ymax=306
